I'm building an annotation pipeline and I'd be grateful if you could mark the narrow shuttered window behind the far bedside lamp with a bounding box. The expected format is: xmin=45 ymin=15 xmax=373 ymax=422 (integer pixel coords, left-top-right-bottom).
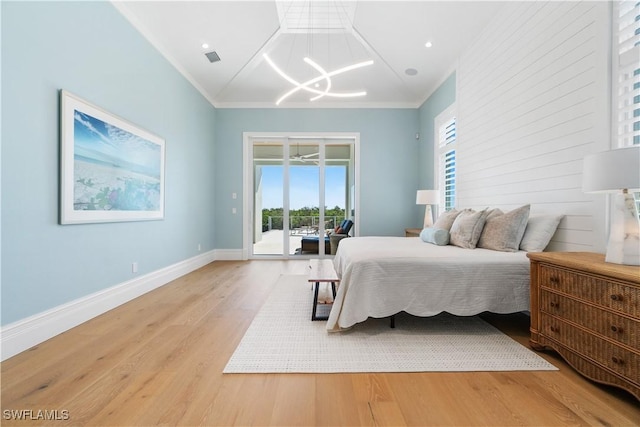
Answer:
xmin=434 ymin=105 xmax=456 ymax=211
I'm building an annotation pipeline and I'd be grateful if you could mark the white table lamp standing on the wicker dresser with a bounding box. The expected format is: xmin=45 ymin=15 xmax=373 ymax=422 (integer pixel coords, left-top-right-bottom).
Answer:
xmin=582 ymin=145 xmax=640 ymax=265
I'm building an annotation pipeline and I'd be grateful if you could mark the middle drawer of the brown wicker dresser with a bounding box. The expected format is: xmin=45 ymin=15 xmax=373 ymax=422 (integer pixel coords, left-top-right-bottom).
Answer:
xmin=540 ymin=290 xmax=640 ymax=348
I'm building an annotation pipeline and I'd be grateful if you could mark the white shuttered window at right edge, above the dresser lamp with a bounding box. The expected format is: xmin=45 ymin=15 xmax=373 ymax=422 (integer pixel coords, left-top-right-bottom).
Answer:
xmin=611 ymin=0 xmax=640 ymax=211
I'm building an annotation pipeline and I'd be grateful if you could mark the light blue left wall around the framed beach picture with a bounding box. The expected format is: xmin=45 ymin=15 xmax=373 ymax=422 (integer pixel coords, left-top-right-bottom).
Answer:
xmin=1 ymin=1 xmax=216 ymax=325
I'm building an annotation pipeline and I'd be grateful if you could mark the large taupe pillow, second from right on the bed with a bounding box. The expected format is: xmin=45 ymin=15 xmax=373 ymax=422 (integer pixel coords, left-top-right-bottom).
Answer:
xmin=478 ymin=205 xmax=531 ymax=252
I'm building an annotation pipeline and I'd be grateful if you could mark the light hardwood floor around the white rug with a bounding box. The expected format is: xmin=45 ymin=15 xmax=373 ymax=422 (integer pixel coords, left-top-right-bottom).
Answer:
xmin=0 ymin=261 xmax=640 ymax=426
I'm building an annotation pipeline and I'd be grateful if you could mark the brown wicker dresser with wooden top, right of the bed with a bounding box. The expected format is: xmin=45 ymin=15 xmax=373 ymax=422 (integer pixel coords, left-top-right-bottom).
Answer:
xmin=528 ymin=252 xmax=640 ymax=400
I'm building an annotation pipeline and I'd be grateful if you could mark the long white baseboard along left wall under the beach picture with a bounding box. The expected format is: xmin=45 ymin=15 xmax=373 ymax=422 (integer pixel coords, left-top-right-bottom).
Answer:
xmin=0 ymin=251 xmax=218 ymax=360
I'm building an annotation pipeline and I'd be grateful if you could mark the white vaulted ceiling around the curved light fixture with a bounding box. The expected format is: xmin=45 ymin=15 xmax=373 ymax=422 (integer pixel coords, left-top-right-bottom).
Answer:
xmin=113 ymin=0 xmax=504 ymax=108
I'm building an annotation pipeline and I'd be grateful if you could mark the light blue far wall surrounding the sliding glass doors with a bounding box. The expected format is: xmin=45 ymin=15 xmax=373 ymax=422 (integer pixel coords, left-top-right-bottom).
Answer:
xmin=215 ymin=108 xmax=419 ymax=249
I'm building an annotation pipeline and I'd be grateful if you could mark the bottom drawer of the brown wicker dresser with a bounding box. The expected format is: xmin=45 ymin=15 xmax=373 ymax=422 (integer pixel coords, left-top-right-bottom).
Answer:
xmin=541 ymin=313 xmax=640 ymax=384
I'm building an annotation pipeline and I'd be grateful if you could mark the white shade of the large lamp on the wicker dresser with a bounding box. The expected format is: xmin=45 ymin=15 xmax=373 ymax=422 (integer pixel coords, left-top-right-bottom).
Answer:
xmin=582 ymin=145 xmax=640 ymax=193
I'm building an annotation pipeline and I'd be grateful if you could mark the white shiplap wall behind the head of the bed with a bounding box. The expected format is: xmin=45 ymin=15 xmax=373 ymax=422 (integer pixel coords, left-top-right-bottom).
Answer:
xmin=456 ymin=2 xmax=610 ymax=252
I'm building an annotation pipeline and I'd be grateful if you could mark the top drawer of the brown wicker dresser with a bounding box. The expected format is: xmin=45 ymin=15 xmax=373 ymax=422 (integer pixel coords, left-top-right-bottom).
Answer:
xmin=540 ymin=264 xmax=640 ymax=317
